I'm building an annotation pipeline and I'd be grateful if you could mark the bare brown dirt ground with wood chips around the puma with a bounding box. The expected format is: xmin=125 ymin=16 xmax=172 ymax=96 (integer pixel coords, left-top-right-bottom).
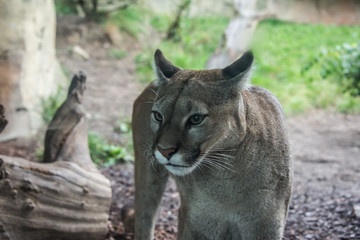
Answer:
xmin=0 ymin=17 xmax=360 ymax=239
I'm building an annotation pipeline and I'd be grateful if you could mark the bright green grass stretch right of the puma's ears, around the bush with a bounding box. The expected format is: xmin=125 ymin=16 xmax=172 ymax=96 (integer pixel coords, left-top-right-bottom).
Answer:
xmin=252 ymin=20 xmax=360 ymax=114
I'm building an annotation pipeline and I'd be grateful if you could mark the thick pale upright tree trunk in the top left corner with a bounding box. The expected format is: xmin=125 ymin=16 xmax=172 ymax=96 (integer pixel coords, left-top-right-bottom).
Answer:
xmin=0 ymin=0 xmax=66 ymax=141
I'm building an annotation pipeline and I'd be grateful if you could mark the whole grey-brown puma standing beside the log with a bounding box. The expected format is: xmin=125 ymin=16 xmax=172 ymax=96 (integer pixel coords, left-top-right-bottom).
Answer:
xmin=132 ymin=50 xmax=292 ymax=240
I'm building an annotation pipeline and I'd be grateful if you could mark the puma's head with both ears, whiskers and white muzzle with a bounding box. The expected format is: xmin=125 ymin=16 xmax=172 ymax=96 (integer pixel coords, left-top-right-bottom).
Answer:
xmin=150 ymin=50 xmax=254 ymax=176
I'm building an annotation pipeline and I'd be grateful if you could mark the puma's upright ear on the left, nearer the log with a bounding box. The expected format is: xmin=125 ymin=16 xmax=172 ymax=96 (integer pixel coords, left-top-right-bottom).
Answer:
xmin=154 ymin=49 xmax=180 ymax=84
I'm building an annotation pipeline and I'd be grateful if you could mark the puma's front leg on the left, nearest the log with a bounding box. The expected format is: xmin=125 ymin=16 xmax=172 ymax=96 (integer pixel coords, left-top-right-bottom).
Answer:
xmin=132 ymin=85 xmax=168 ymax=240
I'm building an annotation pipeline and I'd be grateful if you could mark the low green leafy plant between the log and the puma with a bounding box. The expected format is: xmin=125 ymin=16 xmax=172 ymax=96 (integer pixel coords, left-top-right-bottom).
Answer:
xmin=88 ymin=133 xmax=129 ymax=167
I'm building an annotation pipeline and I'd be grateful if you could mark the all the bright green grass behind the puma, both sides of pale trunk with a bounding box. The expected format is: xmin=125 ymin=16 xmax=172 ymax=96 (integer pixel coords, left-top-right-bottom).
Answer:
xmin=129 ymin=12 xmax=360 ymax=114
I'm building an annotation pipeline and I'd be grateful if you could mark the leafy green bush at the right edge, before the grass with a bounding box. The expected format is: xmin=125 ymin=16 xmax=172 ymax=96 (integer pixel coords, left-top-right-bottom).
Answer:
xmin=303 ymin=43 xmax=360 ymax=96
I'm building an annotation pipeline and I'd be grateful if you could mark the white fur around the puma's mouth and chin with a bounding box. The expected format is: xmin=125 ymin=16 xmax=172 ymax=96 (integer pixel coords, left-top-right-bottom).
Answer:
xmin=155 ymin=150 xmax=197 ymax=176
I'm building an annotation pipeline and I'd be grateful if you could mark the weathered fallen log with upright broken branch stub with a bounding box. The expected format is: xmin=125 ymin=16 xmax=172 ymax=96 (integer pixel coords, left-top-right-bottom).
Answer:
xmin=0 ymin=75 xmax=111 ymax=240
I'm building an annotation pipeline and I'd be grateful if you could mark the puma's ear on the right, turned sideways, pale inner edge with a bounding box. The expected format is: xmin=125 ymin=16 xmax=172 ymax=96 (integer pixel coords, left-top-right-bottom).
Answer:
xmin=222 ymin=51 xmax=254 ymax=89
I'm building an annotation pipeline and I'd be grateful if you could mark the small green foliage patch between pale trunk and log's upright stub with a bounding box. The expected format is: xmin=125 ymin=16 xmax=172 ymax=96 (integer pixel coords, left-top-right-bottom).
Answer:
xmin=41 ymin=87 xmax=66 ymax=124
